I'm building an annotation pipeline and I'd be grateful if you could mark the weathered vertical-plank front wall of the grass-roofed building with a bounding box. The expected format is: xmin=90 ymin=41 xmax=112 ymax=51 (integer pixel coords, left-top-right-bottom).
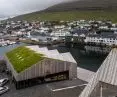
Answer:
xmin=6 ymin=58 xmax=77 ymax=81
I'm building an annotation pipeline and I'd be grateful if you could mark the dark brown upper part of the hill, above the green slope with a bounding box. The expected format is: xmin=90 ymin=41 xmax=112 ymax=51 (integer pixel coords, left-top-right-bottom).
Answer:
xmin=45 ymin=0 xmax=117 ymax=11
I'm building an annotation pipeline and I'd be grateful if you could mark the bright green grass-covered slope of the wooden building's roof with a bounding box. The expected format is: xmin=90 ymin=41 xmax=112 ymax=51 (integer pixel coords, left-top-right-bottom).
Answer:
xmin=6 ymin=46 xmax=44 ymax=73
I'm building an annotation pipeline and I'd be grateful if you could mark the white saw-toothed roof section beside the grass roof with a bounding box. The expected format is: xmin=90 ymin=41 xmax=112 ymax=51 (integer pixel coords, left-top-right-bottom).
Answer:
xmin=27 ymin=45 xmax=77 ymax=63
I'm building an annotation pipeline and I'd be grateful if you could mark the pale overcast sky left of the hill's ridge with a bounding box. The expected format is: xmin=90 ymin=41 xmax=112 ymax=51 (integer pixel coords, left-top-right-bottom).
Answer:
xmin=0 ymin=0 xmax=69 ymax=17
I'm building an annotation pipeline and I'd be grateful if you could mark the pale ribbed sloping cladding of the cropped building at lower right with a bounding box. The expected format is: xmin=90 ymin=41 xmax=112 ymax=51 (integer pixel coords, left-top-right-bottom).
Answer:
xmin=79 ymin=48 xmax=117 ymax=97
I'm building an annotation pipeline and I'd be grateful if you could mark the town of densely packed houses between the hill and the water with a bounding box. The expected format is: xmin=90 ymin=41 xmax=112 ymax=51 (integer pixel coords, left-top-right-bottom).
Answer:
xmin=0 ymin=20 xmax=117 ymax=46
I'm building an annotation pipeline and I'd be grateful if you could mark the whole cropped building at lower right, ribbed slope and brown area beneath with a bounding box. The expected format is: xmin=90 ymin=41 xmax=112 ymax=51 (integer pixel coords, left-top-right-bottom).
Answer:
xmin=79 ymin=48 xmax=117 ymax=97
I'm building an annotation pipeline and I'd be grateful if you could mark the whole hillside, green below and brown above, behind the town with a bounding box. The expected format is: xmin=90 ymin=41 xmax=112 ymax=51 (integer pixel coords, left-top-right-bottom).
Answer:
xmin=10 ymin=0 xmax=117 ymax=22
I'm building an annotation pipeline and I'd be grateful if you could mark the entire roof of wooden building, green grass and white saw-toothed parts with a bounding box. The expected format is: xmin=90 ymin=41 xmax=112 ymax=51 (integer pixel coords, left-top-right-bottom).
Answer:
xmin=6 ymin=45 xmax=76 ymax=73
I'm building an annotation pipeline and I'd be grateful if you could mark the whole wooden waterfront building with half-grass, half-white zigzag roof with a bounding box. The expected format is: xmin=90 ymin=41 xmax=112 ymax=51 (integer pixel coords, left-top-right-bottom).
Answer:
xmin=5 ymin=45 xmax=77 ymax=88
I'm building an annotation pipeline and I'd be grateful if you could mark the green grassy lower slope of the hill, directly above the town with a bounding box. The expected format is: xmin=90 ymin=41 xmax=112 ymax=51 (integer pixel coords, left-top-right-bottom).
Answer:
xmin=13 ymin=11 xmax=117 ymax=22
